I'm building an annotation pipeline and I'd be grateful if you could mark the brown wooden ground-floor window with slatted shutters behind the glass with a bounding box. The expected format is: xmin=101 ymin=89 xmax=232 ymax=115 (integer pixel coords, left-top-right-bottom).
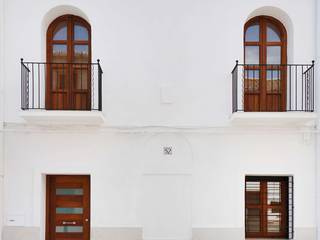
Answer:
xmin=245 ymin=177 xmax=288 ymax=238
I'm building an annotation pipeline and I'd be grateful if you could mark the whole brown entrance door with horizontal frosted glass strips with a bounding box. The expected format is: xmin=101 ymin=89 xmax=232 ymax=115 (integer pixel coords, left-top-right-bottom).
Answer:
xmin=46 ymin=175 xmax=90 ymax=240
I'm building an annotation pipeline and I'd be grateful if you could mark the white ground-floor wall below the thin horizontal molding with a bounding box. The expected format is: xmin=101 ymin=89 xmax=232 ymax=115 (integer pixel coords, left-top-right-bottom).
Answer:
xmin=5 ymin=128 xmax=316 ymax=239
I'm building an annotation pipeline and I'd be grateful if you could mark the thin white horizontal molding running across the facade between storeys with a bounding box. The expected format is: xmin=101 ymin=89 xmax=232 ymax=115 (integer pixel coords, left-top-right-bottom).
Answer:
xmin=0 ymin=122 xmax=320 ymax=134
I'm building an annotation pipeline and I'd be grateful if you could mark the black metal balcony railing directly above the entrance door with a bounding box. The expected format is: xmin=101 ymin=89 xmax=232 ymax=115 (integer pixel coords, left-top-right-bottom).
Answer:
xmin=21 ymin=59 xmax=103 ymax=111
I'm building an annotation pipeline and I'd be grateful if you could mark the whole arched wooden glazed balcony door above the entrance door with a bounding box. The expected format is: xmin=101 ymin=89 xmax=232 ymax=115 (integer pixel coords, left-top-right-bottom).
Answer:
xmin=46 ymin=15 xmax=91 ymax=110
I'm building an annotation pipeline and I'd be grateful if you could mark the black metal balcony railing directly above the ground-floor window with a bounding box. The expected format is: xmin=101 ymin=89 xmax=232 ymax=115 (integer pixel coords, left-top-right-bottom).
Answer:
xmin=232 ymin=61 xmax=315 ymax=112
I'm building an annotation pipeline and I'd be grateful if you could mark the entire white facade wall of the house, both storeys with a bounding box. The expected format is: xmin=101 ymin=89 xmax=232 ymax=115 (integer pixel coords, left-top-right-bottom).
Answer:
xmin=0 ymin=0 xmax=320 ymax=240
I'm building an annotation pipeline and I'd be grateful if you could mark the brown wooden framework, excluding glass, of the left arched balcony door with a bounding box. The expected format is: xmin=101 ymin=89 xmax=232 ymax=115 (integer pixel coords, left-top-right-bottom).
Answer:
xmin=46 ymin=15 xmax=91 ymax=110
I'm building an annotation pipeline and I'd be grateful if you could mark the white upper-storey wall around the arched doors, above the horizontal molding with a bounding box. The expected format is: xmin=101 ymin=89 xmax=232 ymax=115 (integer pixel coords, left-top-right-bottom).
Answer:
xmin=5 ymin=0 xmax=315 ymax=126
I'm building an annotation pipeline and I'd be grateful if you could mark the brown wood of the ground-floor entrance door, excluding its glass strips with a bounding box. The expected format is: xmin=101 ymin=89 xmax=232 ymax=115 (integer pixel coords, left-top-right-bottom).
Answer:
xmin=46 ymin=175 xmax=90 ymax=240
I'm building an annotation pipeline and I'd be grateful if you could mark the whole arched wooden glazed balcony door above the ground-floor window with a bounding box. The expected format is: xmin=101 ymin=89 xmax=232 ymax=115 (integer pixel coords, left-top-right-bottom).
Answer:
xmin=244 ymin=16 xmax=287 ymax=111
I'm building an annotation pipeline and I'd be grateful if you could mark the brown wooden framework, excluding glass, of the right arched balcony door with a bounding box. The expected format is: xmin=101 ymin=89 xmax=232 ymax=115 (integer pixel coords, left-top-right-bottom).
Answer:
xmin=244 ymin=16 xmax=287 ymax=112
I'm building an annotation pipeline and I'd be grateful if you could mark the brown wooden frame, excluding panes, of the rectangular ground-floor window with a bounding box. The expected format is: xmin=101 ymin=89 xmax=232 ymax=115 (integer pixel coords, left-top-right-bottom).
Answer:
xmin=245 ymin=177 xmax=289 ymax=238
